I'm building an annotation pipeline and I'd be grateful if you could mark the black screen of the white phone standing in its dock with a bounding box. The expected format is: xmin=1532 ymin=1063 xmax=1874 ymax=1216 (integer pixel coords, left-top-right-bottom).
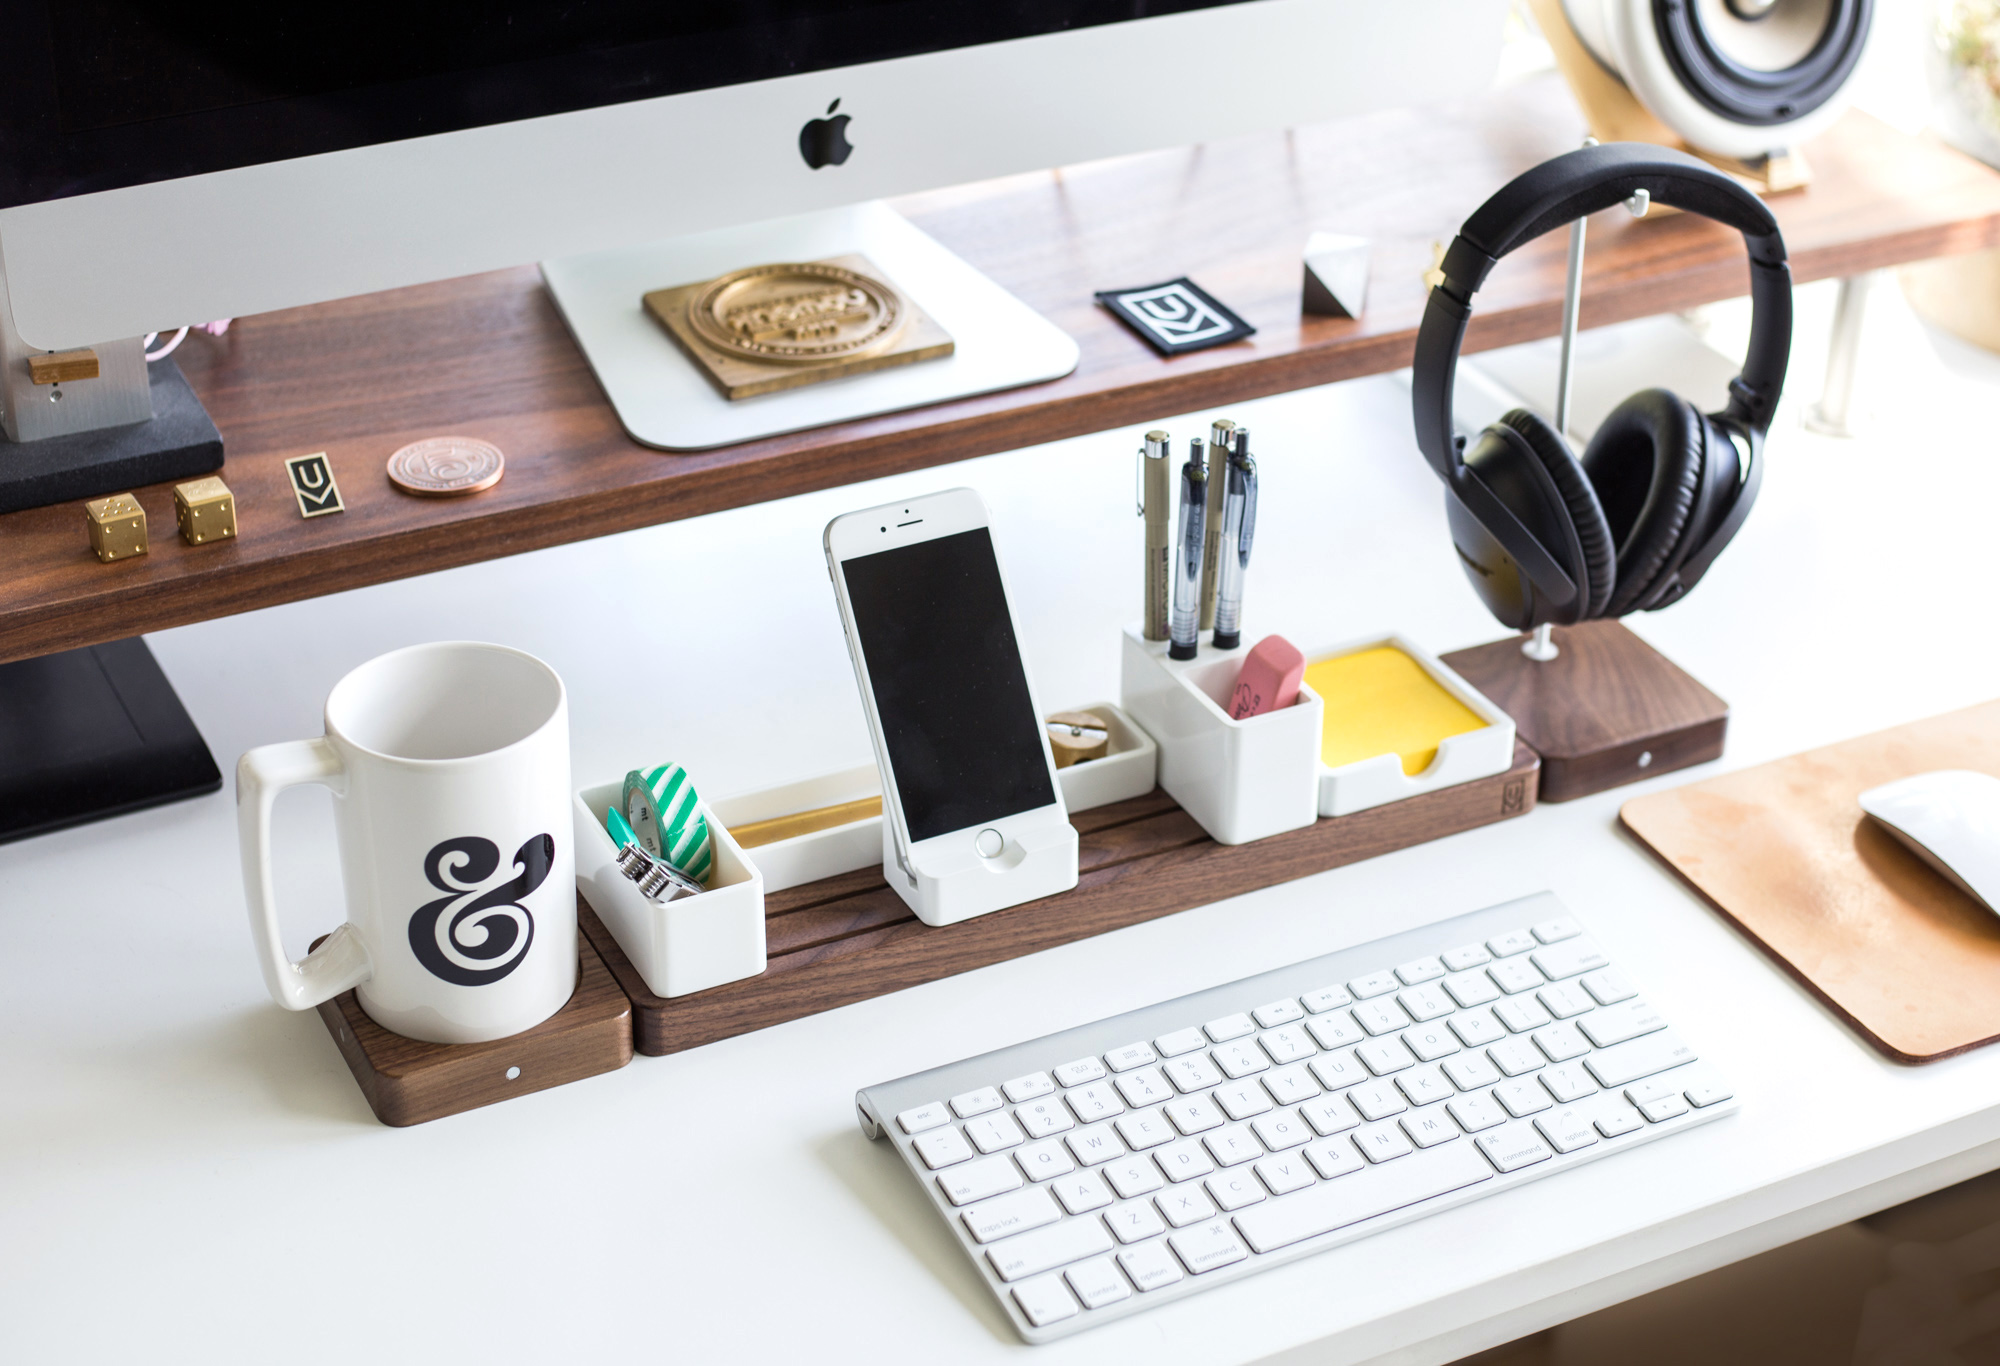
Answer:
xmin=842 ymin=526 xmax=1056 ymax=842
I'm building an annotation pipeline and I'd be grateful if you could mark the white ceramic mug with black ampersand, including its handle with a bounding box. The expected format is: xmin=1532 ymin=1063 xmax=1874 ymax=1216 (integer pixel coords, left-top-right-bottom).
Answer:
xmin=236 ymin=642 xmax=576 ymax=1044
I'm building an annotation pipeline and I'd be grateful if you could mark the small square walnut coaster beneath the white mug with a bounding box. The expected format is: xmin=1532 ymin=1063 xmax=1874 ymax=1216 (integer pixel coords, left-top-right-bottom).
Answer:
xmin=314 ymin=942 xmax=632 ymax=1126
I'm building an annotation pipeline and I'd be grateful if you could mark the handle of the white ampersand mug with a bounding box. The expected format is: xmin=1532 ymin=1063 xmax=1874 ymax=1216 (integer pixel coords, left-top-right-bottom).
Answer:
xmin=236 ymin=740 xmax=374 ymax=1010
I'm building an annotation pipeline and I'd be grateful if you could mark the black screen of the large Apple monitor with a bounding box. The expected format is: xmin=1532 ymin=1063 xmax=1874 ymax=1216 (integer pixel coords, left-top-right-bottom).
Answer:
xmin=0 ymin=0 xmax=1244 ymax=208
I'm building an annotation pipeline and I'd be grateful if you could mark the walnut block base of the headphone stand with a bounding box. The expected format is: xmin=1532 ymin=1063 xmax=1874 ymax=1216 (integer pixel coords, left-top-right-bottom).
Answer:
xmin=1444 ymin=622 xmax=1730 ymax=802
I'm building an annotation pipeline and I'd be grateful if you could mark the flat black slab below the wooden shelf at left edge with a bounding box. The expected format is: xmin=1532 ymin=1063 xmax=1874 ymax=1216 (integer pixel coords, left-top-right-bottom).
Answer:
xmin=0 ymin=638 xmax=222 ymax=842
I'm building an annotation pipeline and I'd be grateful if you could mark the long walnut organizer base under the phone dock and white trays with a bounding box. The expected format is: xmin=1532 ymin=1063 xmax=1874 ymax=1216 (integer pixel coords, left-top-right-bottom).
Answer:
xmin=576 ymin=760 xmax=1540 ymax=1054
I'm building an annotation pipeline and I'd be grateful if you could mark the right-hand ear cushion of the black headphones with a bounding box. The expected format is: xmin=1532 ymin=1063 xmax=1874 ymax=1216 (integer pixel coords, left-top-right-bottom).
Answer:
xmin=1582 ymin=388 xmax=1704 ymax=616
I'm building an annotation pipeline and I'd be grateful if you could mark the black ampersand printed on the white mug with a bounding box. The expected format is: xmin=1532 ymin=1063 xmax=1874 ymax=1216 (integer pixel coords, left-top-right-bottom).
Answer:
xmin=410 ymin=834 xmax=556 ymax=986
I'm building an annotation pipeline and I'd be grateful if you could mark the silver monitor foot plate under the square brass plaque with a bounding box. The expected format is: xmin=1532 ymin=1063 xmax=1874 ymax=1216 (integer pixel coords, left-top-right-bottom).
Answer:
xmin=542 ymin=200 xmax=1080 ymax=450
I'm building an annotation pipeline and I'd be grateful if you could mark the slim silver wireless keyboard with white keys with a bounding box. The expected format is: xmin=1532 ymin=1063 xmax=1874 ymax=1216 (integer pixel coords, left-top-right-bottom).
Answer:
xmin=856 ymin=892 xmax=1738 ymax=1342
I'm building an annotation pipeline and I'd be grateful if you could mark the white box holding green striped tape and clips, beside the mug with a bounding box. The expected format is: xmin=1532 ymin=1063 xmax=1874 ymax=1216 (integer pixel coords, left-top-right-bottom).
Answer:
xmin=574 ymin=782 xmax=764 ymax=996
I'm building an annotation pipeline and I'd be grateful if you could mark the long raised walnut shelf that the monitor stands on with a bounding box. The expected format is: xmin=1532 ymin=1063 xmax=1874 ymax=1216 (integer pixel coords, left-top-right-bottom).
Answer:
xmin=0 ymin=76 xmax=2000 ymax=660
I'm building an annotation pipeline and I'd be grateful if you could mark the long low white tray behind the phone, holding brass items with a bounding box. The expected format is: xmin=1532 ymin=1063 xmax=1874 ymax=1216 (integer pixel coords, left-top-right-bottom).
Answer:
xmin=712 ymin=702 xmax=1160 ymax=892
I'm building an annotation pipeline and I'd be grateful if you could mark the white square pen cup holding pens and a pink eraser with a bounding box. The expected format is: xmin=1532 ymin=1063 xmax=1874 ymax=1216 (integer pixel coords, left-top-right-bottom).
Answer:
xmin=1120 ymin=626 xmax=1322 ymax=844
